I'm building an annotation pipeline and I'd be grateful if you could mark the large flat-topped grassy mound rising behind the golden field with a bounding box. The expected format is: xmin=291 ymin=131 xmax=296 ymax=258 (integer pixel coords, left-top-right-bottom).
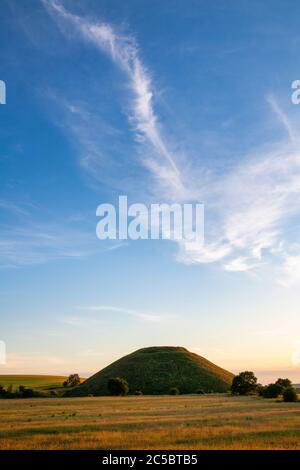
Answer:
xmin=66 ymin=346 xmax=233 ymax=396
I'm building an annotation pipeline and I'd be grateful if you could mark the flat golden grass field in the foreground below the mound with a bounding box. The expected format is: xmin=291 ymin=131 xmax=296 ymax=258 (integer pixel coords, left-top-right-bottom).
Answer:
xmin=0 ymin=394 xmax=300 ymax=449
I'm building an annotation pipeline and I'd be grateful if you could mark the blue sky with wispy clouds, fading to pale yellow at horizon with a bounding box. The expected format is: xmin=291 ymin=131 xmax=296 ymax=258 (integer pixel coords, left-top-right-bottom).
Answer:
xmin=0 ymin=0 xmax=300 ymax=383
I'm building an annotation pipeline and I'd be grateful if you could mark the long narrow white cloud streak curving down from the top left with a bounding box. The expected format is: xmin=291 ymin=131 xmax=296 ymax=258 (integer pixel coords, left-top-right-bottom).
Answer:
xmin=42 ymin=0 xmax=186 ymax=195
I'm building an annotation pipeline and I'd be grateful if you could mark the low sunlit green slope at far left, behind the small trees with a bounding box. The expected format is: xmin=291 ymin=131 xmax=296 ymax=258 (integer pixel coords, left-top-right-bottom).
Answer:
xmin=0 ymin=375 xmax=67 ymax=391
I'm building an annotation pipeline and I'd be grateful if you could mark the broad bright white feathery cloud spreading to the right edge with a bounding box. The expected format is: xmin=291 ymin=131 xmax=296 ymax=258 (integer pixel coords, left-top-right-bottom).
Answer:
xmin=179 ymin=97 xmax=300 ymax=278
